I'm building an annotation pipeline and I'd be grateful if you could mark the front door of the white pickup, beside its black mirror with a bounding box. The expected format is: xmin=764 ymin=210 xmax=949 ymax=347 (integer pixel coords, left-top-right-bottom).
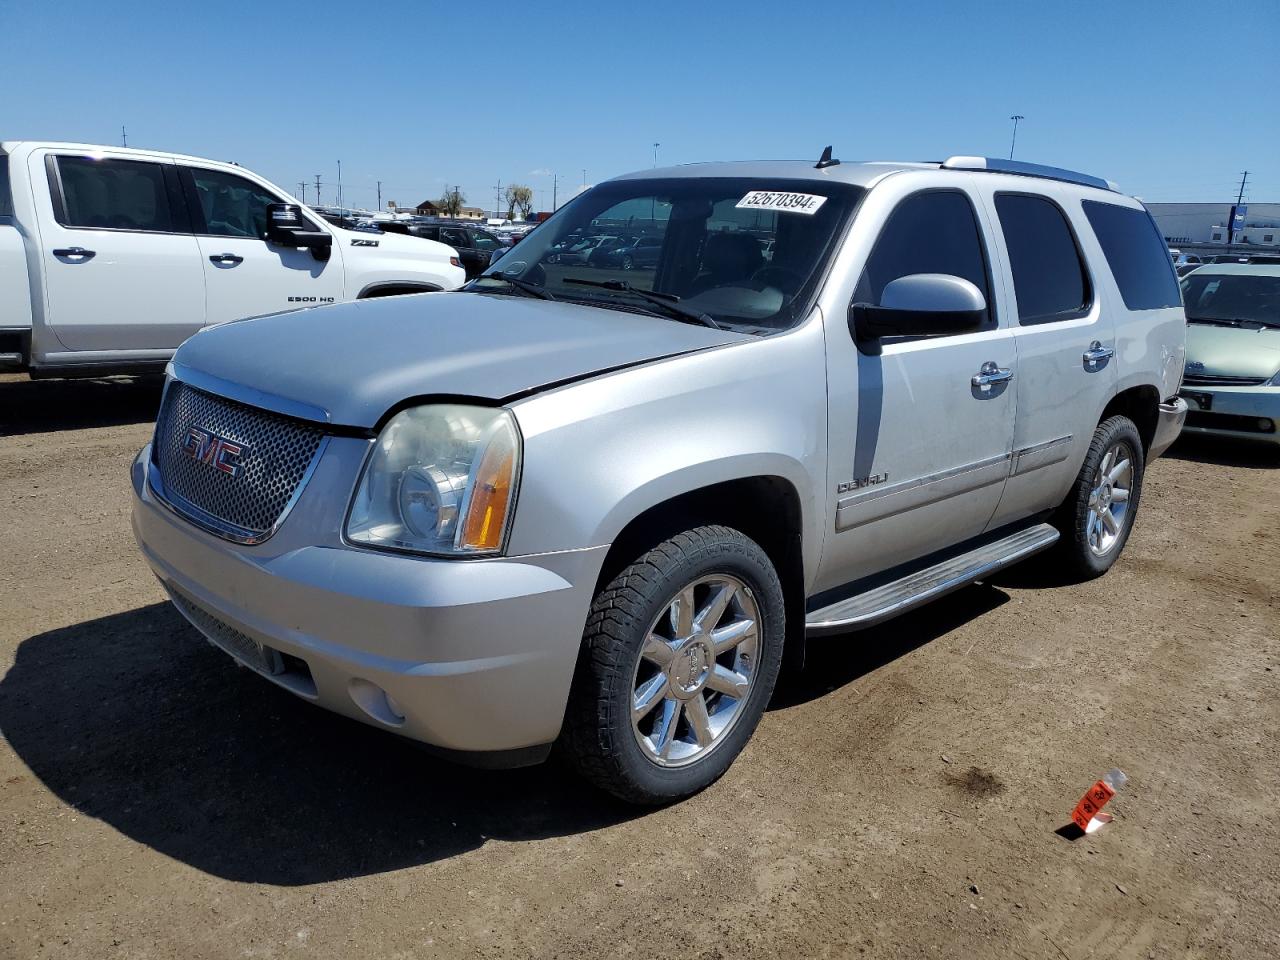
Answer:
xmin=178 ymin=164 xmax=344 ymax=325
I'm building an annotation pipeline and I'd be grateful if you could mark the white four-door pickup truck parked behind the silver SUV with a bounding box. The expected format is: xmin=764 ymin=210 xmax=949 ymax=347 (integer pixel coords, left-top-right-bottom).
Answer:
xmin=0 ymin=141 xmax=466 ymax=378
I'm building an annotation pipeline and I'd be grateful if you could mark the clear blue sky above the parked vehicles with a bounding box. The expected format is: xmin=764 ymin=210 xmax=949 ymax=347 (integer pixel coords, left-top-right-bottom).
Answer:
xmin=0 ymin=0 xmax=1280 ymax=209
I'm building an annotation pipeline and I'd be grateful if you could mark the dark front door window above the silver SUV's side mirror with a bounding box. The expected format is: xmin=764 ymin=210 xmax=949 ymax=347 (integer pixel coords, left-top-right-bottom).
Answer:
xmin=855 ymin=191 xmax=991 ymax=330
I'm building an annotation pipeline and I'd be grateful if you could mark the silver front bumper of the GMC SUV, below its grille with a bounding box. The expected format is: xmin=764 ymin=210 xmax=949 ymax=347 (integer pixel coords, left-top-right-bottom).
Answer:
xmin=132 ymin=440 xmax=607 ymax=765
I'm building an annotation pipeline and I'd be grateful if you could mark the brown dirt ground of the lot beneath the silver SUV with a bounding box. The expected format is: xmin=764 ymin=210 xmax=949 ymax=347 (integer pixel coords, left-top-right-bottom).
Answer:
xmin=0 ymin=376 xmax=1280 ymax=960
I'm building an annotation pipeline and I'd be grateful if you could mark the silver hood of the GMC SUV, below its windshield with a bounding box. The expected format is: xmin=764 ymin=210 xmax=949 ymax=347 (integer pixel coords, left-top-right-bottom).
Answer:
xmin=174 ymin=293 xmax=753 ymax=428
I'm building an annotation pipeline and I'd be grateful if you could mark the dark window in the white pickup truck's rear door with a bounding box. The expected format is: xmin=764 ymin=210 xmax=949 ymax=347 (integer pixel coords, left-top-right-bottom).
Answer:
xmin=58 ymin=156 xmax=174 ymax=232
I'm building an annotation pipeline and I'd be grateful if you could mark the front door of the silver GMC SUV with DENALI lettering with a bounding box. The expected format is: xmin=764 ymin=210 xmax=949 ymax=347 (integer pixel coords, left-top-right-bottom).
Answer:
xmin=817 ymin=178 xmax=1015 ymax=590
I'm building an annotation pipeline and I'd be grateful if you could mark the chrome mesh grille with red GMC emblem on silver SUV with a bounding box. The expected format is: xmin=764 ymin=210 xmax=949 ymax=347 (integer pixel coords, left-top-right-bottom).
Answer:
xmin=152 ymin=380 xmax=325 ymax=543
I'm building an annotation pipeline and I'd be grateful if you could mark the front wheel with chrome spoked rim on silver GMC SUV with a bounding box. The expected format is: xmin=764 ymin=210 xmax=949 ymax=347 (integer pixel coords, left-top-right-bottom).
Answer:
xmin=559 ymin=526 xmax=785 ymax=804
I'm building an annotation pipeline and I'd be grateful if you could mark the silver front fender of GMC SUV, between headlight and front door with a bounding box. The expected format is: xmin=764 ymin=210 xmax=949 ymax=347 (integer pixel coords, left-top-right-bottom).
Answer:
xmin=508 ymin=324 xmax=827 ymax=591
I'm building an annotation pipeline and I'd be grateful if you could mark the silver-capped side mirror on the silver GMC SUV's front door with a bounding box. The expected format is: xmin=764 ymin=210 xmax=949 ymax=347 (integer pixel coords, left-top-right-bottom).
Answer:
xmin=849 ymin=274 xmax=987 ymax=343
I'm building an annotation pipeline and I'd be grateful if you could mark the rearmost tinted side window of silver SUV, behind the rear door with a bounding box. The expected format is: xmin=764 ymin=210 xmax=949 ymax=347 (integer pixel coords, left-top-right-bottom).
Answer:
xmin=1084 ymin=200 xmax=1183 ymax=310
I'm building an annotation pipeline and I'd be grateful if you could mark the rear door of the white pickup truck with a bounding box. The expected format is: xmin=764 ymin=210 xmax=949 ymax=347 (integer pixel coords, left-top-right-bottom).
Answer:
xmin=35 ymin=152 xmax=205 ymax=351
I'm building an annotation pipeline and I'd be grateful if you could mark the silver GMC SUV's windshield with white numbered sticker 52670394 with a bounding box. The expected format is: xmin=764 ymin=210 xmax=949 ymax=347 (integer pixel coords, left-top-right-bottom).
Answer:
xmin=468 ymin=177 xmax=864 ymax=334
